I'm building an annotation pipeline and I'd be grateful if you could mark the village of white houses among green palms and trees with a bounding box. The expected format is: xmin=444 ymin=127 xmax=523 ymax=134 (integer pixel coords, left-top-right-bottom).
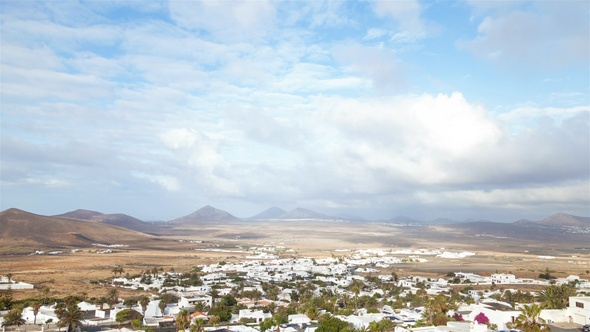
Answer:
xmin=0 ymin=246 xmax=590 ymax=332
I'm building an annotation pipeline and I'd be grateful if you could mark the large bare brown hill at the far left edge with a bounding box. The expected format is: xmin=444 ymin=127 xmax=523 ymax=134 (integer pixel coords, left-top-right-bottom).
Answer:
xmin=0 ymin=209 xmax=153 ymax=253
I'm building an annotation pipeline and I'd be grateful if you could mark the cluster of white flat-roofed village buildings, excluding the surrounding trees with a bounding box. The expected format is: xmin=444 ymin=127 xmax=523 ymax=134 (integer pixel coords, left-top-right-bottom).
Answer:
xmin=1 ymin=249 xmax=590 ymax=332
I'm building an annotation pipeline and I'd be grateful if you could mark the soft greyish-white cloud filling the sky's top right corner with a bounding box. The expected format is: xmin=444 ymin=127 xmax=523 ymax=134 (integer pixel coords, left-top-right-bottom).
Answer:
xmin=459 ymin=1 xmax=590 ymax=68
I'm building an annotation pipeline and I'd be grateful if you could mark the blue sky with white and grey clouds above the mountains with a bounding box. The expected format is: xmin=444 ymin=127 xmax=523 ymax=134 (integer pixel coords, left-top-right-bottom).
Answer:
xmin=0 ymin=0 xmax=590 ymax=222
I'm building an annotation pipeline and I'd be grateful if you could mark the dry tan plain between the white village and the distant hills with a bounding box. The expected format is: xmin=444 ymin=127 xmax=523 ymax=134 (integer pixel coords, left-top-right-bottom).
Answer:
xmin=0 ymin=222 xmax=590 ymax=299
